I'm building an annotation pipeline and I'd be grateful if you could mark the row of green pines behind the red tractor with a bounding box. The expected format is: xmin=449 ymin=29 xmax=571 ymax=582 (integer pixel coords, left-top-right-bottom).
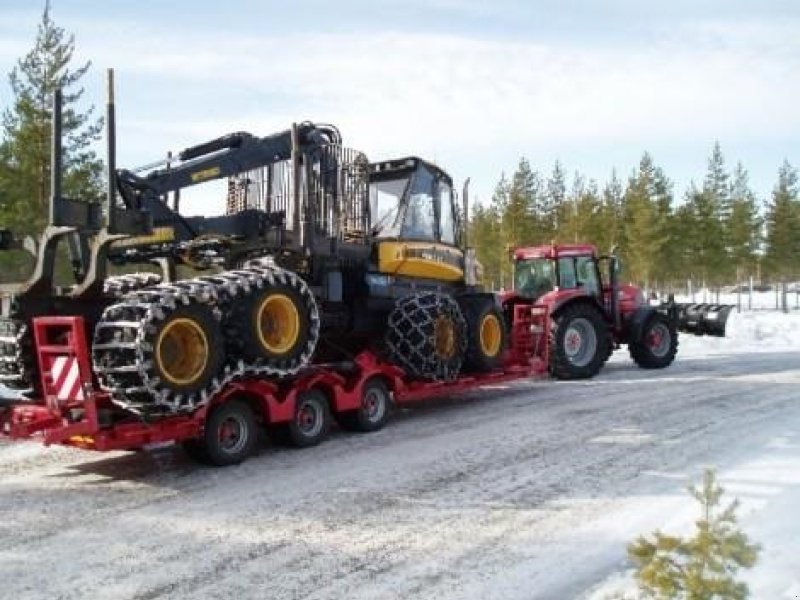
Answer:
xmin=469 ymin=148 xmax=800 ymax=289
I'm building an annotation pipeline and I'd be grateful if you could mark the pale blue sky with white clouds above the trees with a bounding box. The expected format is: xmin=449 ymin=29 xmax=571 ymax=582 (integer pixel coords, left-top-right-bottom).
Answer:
xmin=0 ymin=0 xmax=800 ymax=213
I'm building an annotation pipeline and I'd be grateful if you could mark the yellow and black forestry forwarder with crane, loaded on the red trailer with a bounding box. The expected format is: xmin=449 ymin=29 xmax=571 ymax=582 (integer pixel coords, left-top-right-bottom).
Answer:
xmin=0 ymin=72 xmax=506 ymax=440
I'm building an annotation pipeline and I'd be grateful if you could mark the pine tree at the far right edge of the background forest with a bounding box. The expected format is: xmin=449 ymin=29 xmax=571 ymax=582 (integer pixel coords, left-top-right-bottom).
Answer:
xmin=764 ymin=161 xmax=800 ymax=278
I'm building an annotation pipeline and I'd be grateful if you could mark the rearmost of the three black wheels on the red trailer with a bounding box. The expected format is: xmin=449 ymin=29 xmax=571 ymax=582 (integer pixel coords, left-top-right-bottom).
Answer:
xmin=183 ymin=400 xmax=258 ymax=467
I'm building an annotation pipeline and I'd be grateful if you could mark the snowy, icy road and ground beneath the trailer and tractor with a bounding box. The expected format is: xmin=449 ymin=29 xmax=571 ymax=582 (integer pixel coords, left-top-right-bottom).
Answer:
xmin=0 ymin=315 xmax=800 ymax=600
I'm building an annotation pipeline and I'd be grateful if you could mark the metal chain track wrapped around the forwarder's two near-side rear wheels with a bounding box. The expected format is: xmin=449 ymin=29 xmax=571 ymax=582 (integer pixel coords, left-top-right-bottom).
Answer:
xmin=92 ymin=260 xmax=320 ymax=413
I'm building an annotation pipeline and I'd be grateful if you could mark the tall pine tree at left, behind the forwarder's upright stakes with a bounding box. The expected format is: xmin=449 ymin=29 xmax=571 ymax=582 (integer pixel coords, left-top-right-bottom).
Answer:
xmin=0 ymin=1 xmax=102 ymax=239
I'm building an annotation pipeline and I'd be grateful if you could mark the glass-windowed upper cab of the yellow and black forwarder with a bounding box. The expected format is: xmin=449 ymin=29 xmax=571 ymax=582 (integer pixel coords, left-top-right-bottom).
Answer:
xmin=369 ymin=157 xmax=458 ymax=246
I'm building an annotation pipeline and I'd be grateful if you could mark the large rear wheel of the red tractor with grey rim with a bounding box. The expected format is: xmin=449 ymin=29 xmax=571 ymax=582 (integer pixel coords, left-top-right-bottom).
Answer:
xmin=550 ymin=303 xmax=609 ymax=379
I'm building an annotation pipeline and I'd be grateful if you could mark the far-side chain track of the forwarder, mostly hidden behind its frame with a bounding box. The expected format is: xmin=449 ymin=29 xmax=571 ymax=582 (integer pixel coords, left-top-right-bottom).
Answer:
xmin=0 ymin=273 xmax=161 ymax=391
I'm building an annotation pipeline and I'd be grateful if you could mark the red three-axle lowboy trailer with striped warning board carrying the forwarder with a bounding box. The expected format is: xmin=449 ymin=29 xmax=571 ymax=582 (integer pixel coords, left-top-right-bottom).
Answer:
xmin=0 ymin=303 xmax=550 ymax=466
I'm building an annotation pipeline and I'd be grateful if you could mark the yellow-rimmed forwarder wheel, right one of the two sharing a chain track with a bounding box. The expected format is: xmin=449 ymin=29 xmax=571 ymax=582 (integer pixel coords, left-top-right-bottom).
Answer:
xmin=231 ymin=270 xmax=319 ymax=372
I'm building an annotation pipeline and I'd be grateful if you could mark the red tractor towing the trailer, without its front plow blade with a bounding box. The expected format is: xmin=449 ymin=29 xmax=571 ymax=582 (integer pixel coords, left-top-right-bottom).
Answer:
xmin=502 ymin=244 xmax=678 ymax=379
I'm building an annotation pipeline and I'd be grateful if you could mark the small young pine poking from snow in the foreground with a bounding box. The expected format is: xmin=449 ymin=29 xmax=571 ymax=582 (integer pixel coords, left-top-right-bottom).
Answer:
xmin=628 ymin=469 xmax=760 ymax=600
